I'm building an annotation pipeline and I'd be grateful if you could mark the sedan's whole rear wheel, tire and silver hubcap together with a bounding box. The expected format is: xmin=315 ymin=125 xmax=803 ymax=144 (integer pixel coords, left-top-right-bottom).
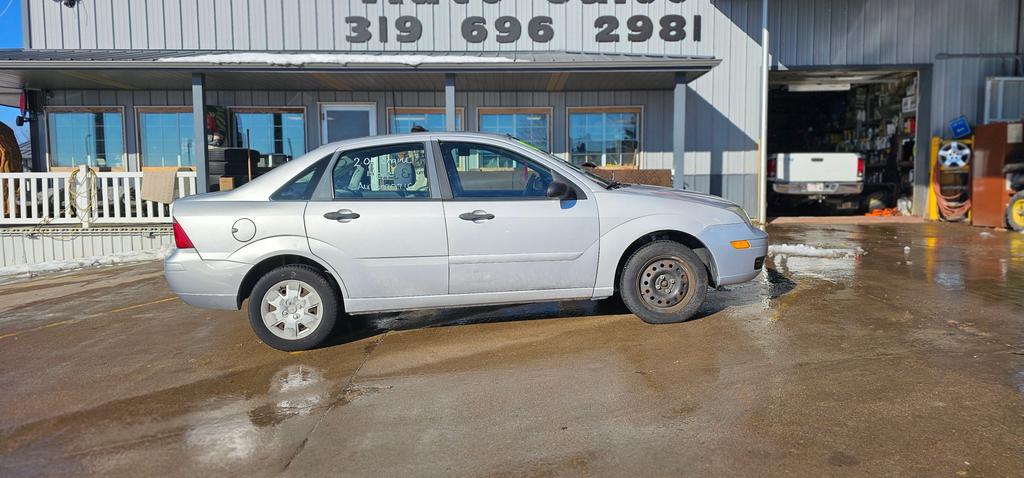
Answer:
xmin=249 ymin=264 xmax=338 ymax=351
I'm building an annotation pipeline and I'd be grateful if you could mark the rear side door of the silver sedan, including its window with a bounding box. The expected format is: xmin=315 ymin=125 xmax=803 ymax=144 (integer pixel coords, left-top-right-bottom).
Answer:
xmin=305 ymin=142 xmax=447 ymax=304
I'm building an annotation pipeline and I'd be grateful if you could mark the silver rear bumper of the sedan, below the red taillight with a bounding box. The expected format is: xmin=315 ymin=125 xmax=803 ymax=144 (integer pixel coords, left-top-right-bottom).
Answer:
xmin=164 ymin=249 xmax=252 ymax=310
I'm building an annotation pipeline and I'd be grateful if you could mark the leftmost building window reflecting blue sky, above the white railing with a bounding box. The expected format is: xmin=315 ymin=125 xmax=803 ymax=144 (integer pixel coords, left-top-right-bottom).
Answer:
xmin=47 ymin=108 xmax=125 ymax=169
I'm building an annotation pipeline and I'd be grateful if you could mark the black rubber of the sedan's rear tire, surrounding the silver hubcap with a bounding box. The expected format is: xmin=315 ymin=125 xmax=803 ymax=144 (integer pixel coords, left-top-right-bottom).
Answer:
xmin=249 ymin=264 xmax=338 ymax=352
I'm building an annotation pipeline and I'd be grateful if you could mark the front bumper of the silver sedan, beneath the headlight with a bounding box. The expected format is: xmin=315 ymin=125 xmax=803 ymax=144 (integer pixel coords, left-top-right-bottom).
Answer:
xmin=700 ymin=224 xmax=768 ymax=286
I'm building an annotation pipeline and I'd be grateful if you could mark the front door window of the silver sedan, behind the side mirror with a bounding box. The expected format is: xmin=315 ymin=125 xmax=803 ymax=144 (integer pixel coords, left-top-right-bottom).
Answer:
xmin=440 ymin=142 xmax=554 ymax=199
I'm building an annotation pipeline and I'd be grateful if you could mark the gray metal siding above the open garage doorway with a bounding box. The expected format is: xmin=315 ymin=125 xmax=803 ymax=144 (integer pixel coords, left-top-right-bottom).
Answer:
xmin=770 ymin=0 xmax=1020 ymax=68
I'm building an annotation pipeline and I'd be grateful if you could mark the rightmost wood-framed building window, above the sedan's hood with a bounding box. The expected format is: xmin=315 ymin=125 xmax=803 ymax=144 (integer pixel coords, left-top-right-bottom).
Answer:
xmin=568 ymin=107 xmax=641 ymax=168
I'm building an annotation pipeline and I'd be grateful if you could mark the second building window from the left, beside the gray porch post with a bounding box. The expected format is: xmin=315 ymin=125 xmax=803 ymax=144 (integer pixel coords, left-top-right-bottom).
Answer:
xmin=138 ymin=108 xmax=196 ymax=168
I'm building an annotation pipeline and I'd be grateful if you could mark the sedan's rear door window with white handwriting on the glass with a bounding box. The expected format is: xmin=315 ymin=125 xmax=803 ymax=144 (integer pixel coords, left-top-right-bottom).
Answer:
xmin=331 ymin=143 xmax=430 ymax=200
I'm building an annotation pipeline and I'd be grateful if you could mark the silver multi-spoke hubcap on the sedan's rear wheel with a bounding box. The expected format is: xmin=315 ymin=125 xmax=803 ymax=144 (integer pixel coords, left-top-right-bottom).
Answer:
xmin=260 ymin=279 xmax=324 ymax=340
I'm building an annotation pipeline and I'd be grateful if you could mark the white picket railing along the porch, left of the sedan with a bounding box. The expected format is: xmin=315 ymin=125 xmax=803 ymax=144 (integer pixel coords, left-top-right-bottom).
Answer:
xmin=0 ymin=171 xmax=196 ymax=225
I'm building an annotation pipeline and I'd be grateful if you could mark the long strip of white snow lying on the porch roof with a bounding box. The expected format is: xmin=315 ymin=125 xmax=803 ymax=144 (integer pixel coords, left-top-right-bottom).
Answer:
xmin=157 ymin=52 xmax=525 ymax=67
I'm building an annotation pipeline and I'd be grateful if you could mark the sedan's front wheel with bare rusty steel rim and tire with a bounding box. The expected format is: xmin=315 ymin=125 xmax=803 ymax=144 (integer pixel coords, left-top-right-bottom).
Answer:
xmin=618 ymin=241 xmax=708 ymax=323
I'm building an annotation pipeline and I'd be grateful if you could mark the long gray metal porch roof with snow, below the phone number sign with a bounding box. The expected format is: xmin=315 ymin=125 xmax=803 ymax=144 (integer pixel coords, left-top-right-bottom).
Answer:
xmin=0 ymin=49 xmax=721 ymax=72
